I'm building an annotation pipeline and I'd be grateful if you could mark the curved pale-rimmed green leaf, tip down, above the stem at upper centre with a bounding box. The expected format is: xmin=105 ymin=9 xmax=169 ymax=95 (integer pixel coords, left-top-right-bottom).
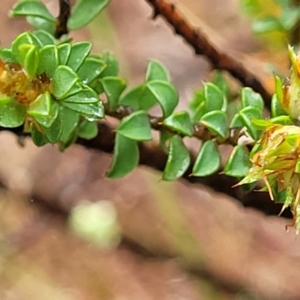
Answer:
xmin=146 ymin=80 xmax=178 ymax=118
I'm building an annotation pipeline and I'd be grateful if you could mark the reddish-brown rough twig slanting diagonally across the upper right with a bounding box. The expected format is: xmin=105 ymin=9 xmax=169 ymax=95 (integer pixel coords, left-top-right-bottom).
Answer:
xmin=145 ymin=0 xmax=271 ymax=108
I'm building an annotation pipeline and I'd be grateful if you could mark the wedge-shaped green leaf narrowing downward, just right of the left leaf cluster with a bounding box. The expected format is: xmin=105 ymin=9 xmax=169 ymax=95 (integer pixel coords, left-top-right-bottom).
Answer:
xmin=101 ymin=76 xmax=126 ymax=111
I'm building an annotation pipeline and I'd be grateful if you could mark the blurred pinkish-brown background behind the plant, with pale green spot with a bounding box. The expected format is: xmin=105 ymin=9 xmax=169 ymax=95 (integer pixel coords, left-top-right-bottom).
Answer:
xmin=0 ymin=0 xmax=300 ymax=300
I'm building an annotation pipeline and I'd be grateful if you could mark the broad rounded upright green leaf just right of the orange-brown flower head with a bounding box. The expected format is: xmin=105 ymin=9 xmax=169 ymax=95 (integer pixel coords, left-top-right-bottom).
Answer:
xmin=52 ymin=66 xmax=78 ymax=99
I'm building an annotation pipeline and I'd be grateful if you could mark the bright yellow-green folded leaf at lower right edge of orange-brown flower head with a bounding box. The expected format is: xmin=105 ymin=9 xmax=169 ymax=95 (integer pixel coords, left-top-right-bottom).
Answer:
xmin=27 ymin=92 xmax=59 ymax=128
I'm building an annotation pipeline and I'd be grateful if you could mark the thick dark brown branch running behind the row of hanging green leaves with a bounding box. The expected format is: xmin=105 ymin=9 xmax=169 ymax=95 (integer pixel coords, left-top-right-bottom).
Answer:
xmin=0 ymin=121 xmax=291 ymax=218
